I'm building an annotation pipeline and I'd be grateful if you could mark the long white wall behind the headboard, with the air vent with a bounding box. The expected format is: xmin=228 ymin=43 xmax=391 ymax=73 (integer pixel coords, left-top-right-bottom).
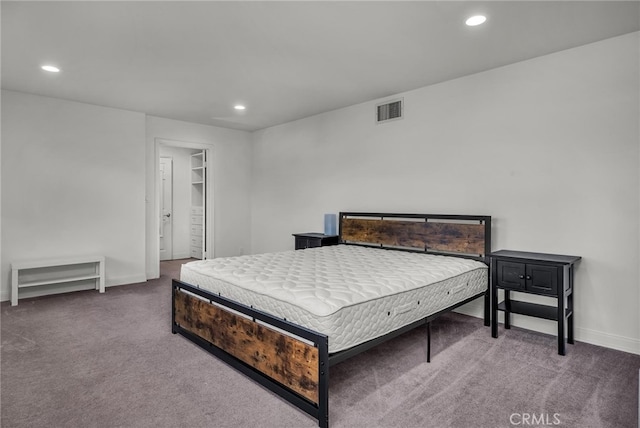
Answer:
xmin=252 ymin=33 xmax=640 ymax=353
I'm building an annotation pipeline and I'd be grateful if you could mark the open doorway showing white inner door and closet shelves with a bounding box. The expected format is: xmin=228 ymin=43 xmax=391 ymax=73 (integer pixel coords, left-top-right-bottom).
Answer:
xmin=156 ymin=140 xmax=213 ymax=263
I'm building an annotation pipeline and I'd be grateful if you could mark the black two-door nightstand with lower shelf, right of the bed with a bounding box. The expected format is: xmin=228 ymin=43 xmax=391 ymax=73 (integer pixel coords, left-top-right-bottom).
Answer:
xmin=491 ymin=250 xmax=581 ymax=355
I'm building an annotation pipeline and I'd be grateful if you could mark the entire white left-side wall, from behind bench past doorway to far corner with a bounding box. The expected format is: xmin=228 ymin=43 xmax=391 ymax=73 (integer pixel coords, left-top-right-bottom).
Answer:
xmin=0 ymin=96 xmax=251 ymax=301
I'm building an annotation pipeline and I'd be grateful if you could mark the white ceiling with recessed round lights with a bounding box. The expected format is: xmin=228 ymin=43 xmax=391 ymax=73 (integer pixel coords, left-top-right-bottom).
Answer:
xmin=1 ymin=1 xmax=640 ymax=130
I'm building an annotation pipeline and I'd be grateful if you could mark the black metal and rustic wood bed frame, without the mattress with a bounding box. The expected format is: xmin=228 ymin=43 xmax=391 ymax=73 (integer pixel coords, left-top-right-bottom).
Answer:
xmin=171 ymin=212 xmax=491 ymax=427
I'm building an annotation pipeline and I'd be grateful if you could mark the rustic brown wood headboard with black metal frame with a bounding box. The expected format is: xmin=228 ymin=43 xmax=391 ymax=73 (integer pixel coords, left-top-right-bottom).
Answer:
xmin=339 ymin=212 xmax=491 ymax=262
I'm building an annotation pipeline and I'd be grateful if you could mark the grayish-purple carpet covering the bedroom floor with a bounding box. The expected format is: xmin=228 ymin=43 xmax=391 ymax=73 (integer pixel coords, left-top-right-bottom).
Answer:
xmin=0 ymin=261 xmax=640 ymax=428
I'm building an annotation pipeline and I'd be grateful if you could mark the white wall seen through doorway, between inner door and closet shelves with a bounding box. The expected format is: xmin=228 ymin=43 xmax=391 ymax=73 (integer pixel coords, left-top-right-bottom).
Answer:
xmin=160 ymin=145 xmax=193 ymax=259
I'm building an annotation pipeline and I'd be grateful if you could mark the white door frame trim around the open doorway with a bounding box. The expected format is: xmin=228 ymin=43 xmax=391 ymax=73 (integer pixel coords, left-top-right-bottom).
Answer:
xmin=151 ymin=138 xmax=215 ymax=275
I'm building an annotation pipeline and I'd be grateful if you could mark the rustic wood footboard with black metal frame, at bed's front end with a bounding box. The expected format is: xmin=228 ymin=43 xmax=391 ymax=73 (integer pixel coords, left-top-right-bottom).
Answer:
xmin=171 ymin=280 xmax=329 ymax=427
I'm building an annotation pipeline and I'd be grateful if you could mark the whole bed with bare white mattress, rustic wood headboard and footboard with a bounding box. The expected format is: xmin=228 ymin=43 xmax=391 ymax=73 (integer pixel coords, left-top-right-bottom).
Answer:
xmin=172 ymin=212 xmax=491 ymax=427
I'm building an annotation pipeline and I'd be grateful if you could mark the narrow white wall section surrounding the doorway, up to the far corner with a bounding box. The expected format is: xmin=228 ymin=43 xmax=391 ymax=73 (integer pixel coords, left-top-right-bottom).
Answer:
xmin=146 ymin=116 xmax=251 ymax=278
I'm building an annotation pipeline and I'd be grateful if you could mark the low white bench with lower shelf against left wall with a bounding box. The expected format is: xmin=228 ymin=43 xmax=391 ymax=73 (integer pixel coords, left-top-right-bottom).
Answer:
xmin=11 ymin=256 xmax=104 ymax=306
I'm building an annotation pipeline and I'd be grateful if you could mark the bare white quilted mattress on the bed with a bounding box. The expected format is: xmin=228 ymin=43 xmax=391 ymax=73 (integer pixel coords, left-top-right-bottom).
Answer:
xmin=180 ymin=245 xmax=488 ymax=353
